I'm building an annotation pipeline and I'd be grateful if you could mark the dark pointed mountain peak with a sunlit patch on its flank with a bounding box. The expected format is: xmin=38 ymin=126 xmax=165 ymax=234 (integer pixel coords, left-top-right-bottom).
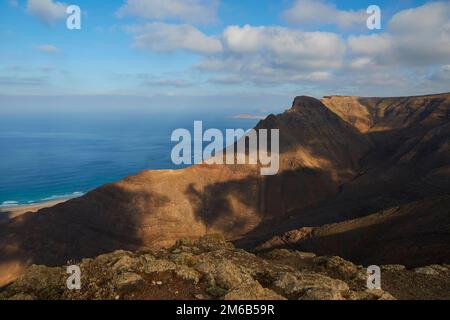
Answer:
xmin=256 ymin=96 xmax=371 ymax=220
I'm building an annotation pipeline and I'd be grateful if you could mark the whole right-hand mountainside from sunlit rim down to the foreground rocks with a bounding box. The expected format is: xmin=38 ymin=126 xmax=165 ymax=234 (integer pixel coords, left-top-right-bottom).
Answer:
xmin=250 ymin=94 xmax=450 ymax=266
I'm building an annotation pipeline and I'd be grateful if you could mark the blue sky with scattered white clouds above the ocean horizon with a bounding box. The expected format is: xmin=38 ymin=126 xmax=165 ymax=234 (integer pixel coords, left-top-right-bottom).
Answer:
xmin=0 ymin=0 xmax=450 ymax=112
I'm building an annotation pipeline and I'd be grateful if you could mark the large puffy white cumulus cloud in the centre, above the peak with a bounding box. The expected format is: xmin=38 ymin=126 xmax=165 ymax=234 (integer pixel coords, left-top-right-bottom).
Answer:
xmin=198 ymin=25 xmax=345 ymax=84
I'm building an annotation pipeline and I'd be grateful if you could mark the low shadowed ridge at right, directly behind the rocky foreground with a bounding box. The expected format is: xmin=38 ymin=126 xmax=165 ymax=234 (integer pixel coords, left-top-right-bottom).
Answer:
xmin=253 ymin=196 xmax=450 ymax=267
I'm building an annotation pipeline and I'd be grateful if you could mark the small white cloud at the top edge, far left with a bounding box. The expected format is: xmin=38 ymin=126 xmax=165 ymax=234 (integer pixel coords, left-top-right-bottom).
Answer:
xmin=27 ymin=0 xmax=67 ymax=25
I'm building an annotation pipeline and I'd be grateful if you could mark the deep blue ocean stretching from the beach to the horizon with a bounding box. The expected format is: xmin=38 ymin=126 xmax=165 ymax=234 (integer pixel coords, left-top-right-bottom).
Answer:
xmin=0 ymin=113 xmax=258 ymax=207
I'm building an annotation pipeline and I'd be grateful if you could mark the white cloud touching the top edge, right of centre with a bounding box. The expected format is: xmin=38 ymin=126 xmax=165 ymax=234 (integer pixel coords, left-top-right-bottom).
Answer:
xmin=284 ymin=0 xmax=367 ymax=29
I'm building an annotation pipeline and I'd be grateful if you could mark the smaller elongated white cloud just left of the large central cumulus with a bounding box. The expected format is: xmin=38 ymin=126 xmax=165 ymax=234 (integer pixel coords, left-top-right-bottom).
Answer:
xmin=127 ymin=22 xmax=222 ymax=54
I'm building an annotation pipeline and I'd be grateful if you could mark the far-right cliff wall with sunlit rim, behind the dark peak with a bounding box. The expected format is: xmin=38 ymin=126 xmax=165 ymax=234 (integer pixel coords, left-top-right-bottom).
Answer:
xmin=318 ymin=94 xmax=450 ymax=215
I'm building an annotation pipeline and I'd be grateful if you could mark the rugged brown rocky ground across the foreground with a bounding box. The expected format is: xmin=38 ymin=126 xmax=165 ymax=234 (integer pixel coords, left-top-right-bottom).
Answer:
xmin=0 ymin=236 xmax=450 ymax=300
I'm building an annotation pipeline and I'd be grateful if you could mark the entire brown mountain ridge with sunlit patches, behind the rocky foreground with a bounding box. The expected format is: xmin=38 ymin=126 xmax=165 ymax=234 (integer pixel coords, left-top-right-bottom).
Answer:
xmin=0 ymin=94 xmax=450 ymax=288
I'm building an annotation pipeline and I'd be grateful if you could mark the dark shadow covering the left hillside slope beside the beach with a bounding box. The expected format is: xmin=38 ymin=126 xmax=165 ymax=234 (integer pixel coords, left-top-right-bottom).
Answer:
xmin=0 ymin=184 xmax=167 ymax=282
